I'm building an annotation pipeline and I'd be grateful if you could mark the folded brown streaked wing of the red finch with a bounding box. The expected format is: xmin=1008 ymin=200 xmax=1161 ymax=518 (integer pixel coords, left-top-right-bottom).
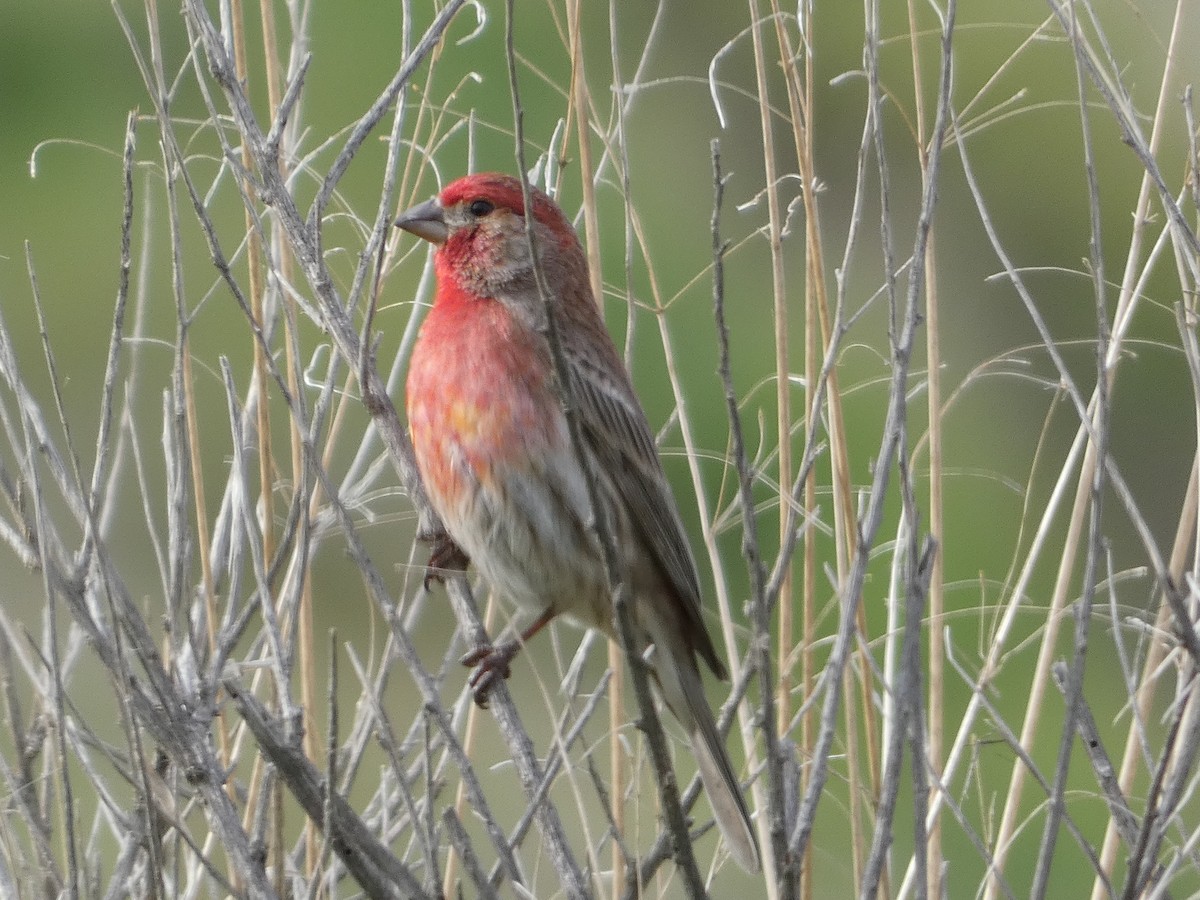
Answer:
xmin=564 ymin=348 xmax=725 ymax=678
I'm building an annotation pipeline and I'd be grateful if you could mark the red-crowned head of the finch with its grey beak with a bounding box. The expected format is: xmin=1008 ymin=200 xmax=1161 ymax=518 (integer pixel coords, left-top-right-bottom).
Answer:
xmin=396 ymin=173 xmax=587 ymax=319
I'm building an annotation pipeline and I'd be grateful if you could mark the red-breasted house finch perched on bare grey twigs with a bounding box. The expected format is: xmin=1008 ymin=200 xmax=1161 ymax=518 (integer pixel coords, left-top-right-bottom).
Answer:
xmin=396 ymin=174 xmax=760 ymax=871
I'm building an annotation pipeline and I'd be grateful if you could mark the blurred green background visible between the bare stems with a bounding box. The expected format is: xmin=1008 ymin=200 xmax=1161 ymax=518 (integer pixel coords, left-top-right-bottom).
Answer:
xmin=0 ymin=0 xmax=1200 ymax=896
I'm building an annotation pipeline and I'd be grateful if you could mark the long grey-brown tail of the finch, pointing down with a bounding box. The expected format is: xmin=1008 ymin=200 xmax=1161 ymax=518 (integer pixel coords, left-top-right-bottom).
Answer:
xmin=648 ymin=626 xmax=762 ymax=872
